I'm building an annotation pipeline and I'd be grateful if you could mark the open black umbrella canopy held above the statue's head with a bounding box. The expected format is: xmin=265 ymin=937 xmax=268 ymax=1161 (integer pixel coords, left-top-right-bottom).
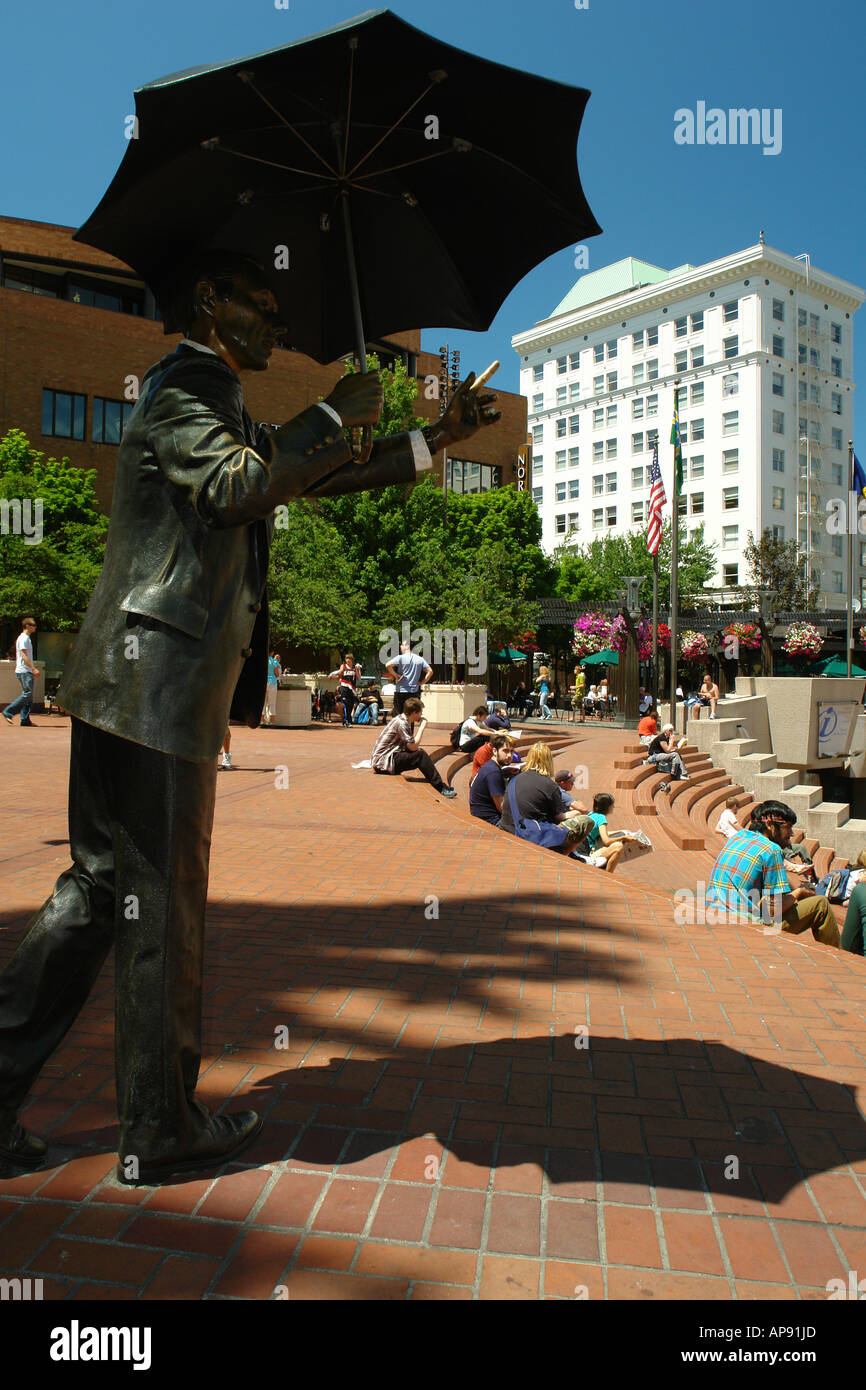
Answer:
xmin=75 ymin=10 xmax=601 ymax=361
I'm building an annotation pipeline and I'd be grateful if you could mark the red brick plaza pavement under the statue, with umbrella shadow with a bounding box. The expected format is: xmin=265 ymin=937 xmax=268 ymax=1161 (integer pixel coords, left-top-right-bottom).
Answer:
xmin=0 ymin=716 xmax=866 ymax=1300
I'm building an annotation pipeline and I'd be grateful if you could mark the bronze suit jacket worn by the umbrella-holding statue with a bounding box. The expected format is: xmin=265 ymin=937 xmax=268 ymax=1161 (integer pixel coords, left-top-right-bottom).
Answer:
xmin=58 ymin=343 xmax=416 ymax=762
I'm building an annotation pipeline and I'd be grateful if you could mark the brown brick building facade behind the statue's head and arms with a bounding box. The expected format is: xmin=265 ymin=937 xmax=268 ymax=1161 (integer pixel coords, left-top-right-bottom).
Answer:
xmin=0 ymin=217 xmax=527 ymax=510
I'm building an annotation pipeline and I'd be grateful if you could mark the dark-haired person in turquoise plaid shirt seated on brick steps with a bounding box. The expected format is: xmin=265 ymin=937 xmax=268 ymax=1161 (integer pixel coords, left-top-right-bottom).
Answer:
xmin=706 ymin=801 xmax=840 ymax=947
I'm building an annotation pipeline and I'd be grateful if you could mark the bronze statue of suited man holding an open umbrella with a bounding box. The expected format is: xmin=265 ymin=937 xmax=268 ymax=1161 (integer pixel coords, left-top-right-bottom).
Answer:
xmin=0 ymin=11 xmax=598 ymax=1183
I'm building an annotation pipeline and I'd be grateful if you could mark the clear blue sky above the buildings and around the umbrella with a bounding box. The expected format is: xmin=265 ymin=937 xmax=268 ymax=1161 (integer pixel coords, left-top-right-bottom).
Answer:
xmin=0 ymin=0 xmax=866 ymax=428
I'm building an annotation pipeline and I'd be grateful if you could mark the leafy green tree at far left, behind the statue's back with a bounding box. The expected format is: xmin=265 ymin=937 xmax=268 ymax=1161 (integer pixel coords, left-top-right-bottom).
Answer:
xmin=0 ymin=430 xmax=107 ymax=649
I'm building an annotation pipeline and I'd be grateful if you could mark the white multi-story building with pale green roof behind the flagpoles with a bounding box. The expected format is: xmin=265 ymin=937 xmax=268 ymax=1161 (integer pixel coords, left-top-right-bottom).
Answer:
xmin=512 ymin=242 xmax=866 ymax=607
